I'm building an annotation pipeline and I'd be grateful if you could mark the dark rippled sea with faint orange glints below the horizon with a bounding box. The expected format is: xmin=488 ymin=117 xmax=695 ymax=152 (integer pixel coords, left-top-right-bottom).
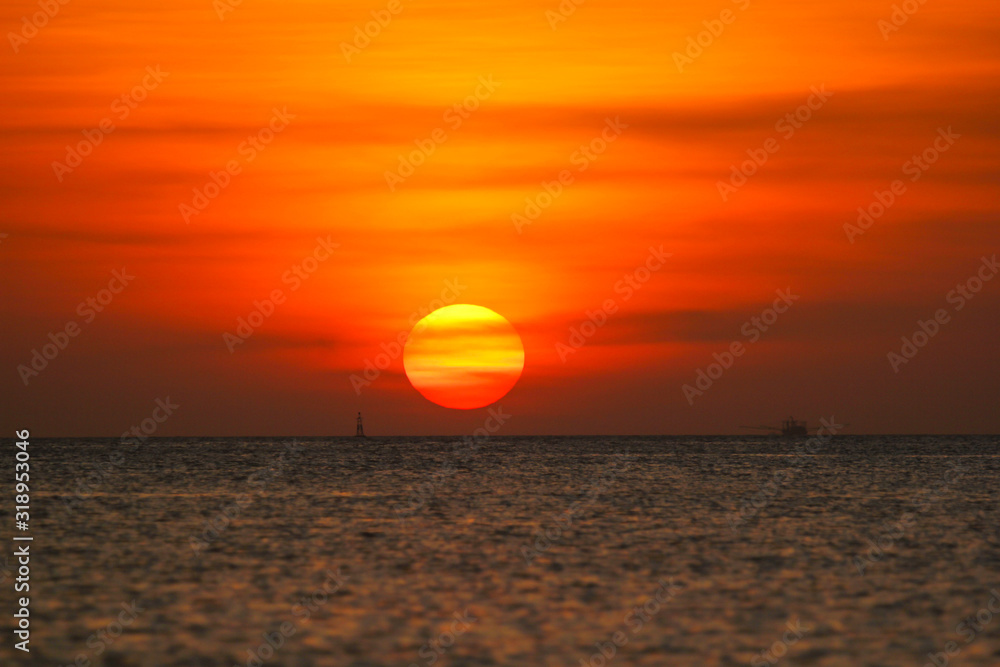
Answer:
xmin=0 ymin=436 xmax=1000 ymax=667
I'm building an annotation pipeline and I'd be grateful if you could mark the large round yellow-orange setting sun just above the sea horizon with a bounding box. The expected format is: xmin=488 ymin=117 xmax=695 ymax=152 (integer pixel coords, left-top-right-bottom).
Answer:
xmin=403 ymin=303 xmax=524 ymax=410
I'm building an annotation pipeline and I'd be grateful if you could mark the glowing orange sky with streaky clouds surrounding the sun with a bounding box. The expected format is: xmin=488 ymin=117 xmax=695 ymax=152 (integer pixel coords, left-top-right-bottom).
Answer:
xmin=0 ymin=0 xmax=1000 ymax=436
